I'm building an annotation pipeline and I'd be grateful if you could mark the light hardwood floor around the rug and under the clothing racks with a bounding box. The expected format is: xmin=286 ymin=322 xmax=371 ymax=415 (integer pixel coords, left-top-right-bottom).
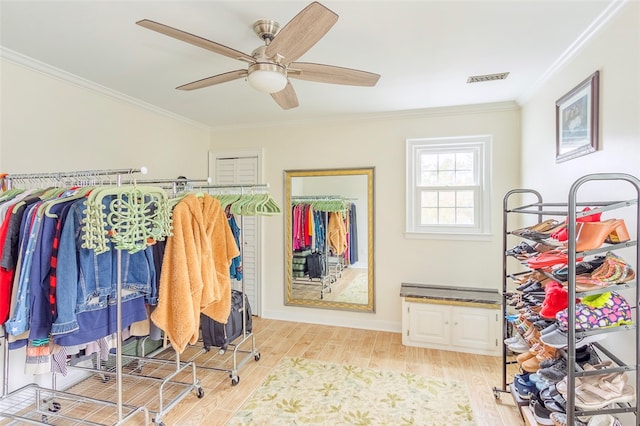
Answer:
xmin=0 ymin=317 xmax=524 ymax=426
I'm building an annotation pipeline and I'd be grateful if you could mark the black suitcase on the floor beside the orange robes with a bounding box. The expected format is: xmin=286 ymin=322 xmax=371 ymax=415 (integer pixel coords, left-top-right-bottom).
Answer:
xmin=200 ymin=290 xmax=251 ymax=351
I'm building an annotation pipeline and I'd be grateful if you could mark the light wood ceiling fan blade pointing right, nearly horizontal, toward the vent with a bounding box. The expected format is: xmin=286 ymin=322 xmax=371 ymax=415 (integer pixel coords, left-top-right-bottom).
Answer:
xmin=287 ymin=62 xmax=380 ymax=87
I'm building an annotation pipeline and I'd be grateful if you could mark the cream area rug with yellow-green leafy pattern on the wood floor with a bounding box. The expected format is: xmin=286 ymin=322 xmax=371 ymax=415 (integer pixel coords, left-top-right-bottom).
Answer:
xmin=227 ymin=358 xmax=475 ymax=426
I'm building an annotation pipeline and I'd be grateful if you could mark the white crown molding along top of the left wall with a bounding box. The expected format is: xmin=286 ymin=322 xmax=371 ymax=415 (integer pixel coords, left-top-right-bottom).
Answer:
xmin=0 ymin=46 xmax=210 ymax=129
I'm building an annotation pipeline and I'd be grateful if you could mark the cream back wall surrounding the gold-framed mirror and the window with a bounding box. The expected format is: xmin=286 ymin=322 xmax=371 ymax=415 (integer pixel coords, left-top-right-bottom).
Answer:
xmin=211 ymin=103 xmax=520 ymax=331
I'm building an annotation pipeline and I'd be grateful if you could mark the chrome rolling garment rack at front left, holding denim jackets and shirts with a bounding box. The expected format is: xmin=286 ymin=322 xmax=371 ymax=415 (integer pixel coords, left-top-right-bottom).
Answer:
xmin=0 ymin=167 xmax=204 ymax=425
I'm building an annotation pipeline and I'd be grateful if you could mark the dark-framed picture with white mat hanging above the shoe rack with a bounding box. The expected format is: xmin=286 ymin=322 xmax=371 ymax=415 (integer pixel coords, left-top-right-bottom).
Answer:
xmin=556 ymin=71 xmax=600 ymax=163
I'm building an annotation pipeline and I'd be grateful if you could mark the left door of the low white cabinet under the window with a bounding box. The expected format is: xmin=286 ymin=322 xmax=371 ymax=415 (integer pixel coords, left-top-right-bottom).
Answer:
xmin=407 ymin=303 xmax=451 ymax=345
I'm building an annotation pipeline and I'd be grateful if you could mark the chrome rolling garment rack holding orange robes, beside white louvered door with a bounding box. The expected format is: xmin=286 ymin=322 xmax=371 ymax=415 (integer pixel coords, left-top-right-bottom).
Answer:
xmin=158 ymin=184 xmax=276 ymax=386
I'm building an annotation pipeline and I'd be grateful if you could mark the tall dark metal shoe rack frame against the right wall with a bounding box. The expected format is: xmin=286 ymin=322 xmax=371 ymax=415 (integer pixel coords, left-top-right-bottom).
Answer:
xmin=493 ymin=173 xmax=640 ymax=425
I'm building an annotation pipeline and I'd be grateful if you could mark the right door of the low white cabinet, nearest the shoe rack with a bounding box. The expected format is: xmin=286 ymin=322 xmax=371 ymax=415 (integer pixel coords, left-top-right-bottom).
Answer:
xmin=451 ymin=306 xmax=498 ymax=351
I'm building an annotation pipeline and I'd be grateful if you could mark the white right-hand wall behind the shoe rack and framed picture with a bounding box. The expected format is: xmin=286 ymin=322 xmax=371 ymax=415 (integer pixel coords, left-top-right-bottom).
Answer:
xmin=521 ymin=1 xmax=640 ymax=425
